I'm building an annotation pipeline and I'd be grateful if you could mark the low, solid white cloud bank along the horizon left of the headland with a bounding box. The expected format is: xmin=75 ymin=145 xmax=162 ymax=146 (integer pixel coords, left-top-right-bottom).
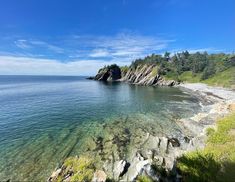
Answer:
xmin=0 ymin=56 xmax=130 ymax=75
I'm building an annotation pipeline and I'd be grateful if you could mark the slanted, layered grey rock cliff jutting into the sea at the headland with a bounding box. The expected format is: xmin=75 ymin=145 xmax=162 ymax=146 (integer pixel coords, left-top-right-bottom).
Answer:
xmin=93 ymin=64 xmax=178 ymax=86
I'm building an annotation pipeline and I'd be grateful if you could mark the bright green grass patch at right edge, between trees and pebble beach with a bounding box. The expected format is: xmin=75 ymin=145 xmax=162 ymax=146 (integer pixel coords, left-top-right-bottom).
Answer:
xmin=202 ymin=67 xmax=235 ymax=88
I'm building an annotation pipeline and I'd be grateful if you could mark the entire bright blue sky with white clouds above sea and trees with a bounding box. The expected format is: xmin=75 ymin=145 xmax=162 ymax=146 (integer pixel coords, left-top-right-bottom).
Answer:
xmin=0 ymin=0 xmax=235 ymax=76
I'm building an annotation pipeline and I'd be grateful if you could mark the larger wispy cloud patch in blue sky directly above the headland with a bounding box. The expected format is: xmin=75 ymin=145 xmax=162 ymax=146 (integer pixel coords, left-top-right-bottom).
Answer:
xmin=70 ymin=33 xmax=175 ymax=59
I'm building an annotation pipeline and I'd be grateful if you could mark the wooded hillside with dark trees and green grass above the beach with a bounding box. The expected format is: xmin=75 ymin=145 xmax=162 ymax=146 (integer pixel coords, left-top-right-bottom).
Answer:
xmin=130 ymin=51 xmax=235 ymax=87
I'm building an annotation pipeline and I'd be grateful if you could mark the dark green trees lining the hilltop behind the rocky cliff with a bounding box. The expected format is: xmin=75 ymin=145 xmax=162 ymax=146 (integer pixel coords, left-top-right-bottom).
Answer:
xmin=130 ymin=51 xmax=235 ymax=80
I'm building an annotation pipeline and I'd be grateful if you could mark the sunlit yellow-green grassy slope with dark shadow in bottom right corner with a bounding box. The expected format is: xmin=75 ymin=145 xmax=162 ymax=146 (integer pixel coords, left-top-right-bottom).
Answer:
xmin=177 ymin=113 xmax=235 ymax=182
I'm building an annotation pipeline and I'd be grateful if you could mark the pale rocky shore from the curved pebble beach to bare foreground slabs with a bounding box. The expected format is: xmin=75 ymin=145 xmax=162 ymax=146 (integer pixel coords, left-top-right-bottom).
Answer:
xmin=48 ymin=83 xmax=235 ymax=181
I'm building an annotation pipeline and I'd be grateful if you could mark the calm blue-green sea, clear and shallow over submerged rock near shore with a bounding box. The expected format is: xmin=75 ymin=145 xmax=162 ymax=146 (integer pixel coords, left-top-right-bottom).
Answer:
xmin=0 ymin=76 xmax=200 ymax=180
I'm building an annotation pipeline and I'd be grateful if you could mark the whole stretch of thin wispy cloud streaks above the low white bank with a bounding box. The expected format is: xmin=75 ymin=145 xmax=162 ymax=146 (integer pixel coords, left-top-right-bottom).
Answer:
xmin=10 ymin=32 xmax=175 ymax=61
